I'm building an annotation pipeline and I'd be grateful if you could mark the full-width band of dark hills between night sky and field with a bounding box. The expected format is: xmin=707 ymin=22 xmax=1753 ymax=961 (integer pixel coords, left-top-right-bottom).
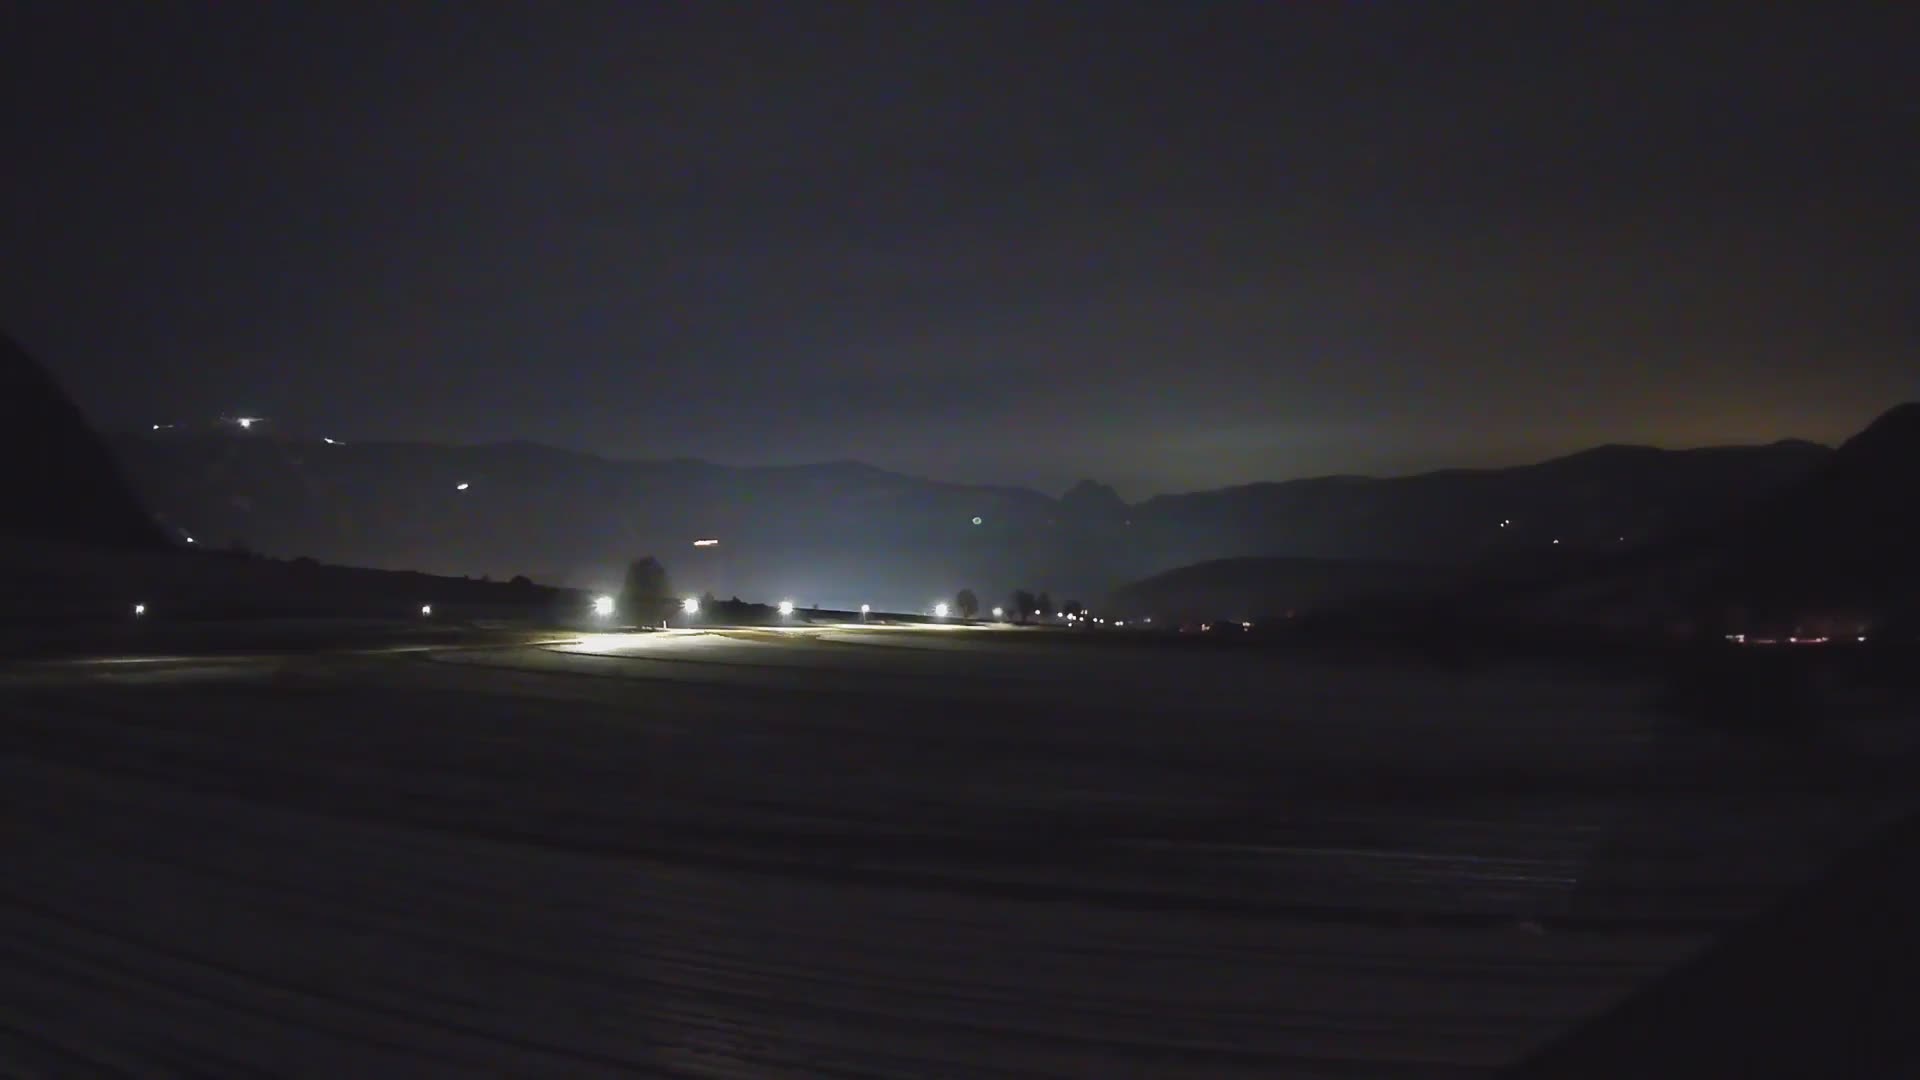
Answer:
xmin=0 ymin=322 xmax=1920 ymax=626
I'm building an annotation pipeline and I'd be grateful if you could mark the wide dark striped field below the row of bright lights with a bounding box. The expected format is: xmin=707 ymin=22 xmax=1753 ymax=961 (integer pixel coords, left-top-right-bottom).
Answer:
xmin=0 ymin=628 xmax=1910 ymax=1078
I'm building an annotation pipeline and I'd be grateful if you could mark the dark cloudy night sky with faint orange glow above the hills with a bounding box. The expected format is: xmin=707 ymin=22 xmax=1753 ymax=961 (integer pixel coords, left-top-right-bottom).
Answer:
xmin=0 ymin=0 xmax=1920 ymax=498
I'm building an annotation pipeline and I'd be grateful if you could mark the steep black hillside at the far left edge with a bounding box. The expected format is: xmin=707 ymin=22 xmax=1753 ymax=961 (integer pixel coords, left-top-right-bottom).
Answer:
xmin=0 ymin=332 xmax=169 ymax=550
